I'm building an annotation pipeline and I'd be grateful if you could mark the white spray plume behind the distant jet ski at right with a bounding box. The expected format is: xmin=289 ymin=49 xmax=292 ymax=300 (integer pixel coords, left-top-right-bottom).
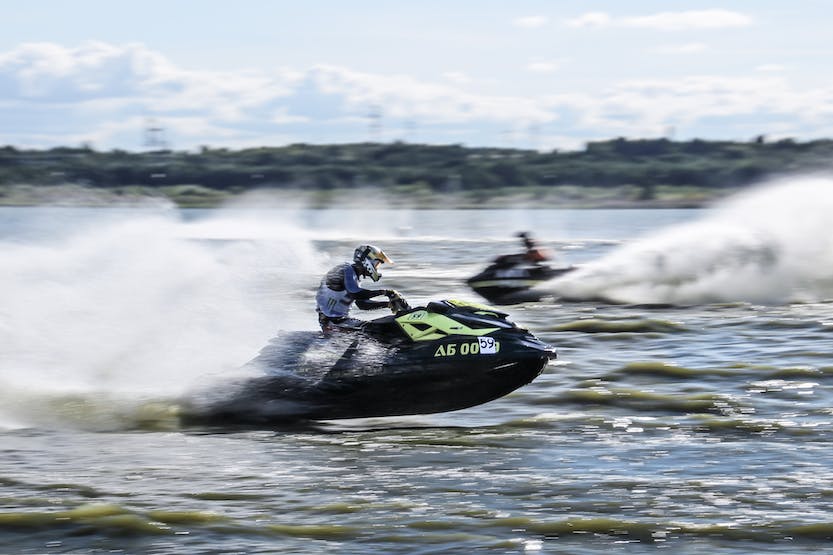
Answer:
xmin=551 ymin=176 xmax=833 ymax=304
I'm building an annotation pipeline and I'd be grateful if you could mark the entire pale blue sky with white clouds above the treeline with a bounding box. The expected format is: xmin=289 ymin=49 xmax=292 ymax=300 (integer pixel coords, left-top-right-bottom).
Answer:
xmin=0 ymin=0 xmax=833 ymax=151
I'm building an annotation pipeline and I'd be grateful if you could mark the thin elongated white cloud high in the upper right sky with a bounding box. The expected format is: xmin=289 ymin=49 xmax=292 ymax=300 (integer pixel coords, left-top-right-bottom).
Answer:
xmin=567 ymin=9 xmax=752 ymax=31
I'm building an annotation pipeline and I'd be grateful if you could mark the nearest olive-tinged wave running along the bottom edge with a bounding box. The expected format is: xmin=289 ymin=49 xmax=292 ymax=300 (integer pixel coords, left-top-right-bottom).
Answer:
xmin=0 ymin=500 xmax=833 ymax=549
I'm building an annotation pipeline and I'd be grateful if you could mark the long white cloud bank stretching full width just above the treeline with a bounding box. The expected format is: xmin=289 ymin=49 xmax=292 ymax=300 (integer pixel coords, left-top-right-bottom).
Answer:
xmin=0 ymin=39 xmax=833 ymax=150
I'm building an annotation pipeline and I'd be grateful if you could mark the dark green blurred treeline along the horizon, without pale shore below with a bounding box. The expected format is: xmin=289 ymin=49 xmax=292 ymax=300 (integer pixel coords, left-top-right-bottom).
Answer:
xmin=0 ymin=137 xmax=833 ymax=198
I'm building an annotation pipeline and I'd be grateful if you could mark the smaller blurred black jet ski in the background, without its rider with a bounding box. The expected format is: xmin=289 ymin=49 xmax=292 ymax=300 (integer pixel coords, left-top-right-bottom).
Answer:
xmin=466 ymin=255 xmax=575 ymax=305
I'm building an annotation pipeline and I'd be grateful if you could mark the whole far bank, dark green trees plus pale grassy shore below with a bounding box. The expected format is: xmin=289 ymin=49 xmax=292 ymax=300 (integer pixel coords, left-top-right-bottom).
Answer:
xmin=0 ymin=137 xmax=833 ymax=207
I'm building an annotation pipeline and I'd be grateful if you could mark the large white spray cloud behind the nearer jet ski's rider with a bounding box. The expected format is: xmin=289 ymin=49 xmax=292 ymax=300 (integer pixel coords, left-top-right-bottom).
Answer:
xmin=0 ymin=211 xmax=321 ymax=425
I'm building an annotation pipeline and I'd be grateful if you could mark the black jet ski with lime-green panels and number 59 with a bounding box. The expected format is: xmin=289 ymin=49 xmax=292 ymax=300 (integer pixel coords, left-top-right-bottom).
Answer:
xmin=183 ymin=300 xmax=556 ymax=425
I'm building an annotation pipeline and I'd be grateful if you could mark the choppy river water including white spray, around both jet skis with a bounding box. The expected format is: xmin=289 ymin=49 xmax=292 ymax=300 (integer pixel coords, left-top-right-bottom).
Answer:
xmin=0 ymin=178 xmax=833 ymax=554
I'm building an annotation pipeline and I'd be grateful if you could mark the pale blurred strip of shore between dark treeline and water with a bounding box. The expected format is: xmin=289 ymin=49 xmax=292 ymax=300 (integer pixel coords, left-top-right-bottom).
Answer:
xmin=0 ymin=184 xmax=738 ymax=210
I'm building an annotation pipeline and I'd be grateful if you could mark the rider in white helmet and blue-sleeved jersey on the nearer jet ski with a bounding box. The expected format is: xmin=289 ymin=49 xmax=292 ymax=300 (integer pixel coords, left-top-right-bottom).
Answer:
xmin=315 ymin=245 xmax=399 ymax=331
